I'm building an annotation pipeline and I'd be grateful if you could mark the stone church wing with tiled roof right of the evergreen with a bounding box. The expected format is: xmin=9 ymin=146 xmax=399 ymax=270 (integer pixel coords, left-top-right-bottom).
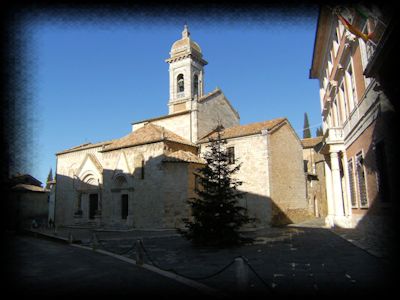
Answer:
xmin=198 ymin=118 xmax=310 ymax=227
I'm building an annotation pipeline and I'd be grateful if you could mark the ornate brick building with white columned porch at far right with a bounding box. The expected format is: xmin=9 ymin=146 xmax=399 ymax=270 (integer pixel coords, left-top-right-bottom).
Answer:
xmin=310 ymin=6 xmax=397 ymax=227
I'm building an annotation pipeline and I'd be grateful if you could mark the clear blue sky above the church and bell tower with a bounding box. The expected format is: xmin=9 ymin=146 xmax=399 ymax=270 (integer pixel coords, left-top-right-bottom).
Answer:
xmin=19 ymin=10 xmax=321 ymax=182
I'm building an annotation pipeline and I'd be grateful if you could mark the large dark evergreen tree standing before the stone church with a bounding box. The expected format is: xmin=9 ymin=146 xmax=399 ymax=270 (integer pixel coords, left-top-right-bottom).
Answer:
xmin=180 ymin=126 xmax=254 ymax=246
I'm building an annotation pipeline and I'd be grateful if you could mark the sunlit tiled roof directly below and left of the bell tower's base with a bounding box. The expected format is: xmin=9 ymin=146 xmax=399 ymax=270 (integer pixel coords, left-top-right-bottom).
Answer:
xmin=102 ymin=123 xmax=196 ymax=151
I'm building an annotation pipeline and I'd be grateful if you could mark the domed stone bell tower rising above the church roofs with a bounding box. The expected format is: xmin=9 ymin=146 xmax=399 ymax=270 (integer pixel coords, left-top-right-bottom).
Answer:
xmin=165 ymin=25 xmax=207 ymax=114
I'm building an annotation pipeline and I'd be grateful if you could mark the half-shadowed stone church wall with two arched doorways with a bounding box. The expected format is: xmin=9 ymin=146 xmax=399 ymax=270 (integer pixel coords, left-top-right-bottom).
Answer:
xmin=56 ymin=142 xmax=195 ymax=228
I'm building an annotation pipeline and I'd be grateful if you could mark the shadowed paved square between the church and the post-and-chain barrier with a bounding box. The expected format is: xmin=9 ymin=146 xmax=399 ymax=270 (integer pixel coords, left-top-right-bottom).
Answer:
xmin=28 ymin=224 xmax=393 ymax=296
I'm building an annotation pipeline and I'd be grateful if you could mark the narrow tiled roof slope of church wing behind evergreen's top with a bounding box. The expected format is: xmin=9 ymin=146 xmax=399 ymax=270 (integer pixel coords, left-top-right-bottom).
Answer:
xmin=198 ymin=118 xmax=286 ymax=143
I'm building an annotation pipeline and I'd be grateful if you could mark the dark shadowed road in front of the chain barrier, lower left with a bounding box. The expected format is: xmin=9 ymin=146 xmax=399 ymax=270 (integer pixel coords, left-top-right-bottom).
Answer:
xmin=6 ymin=235 xmax=205 ymax=299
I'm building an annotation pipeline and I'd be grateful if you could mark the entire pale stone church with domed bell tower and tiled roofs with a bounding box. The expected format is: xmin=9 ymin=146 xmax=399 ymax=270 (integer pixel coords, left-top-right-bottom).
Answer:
xmin=55 ymin=26 xmax=308 ymax=229
